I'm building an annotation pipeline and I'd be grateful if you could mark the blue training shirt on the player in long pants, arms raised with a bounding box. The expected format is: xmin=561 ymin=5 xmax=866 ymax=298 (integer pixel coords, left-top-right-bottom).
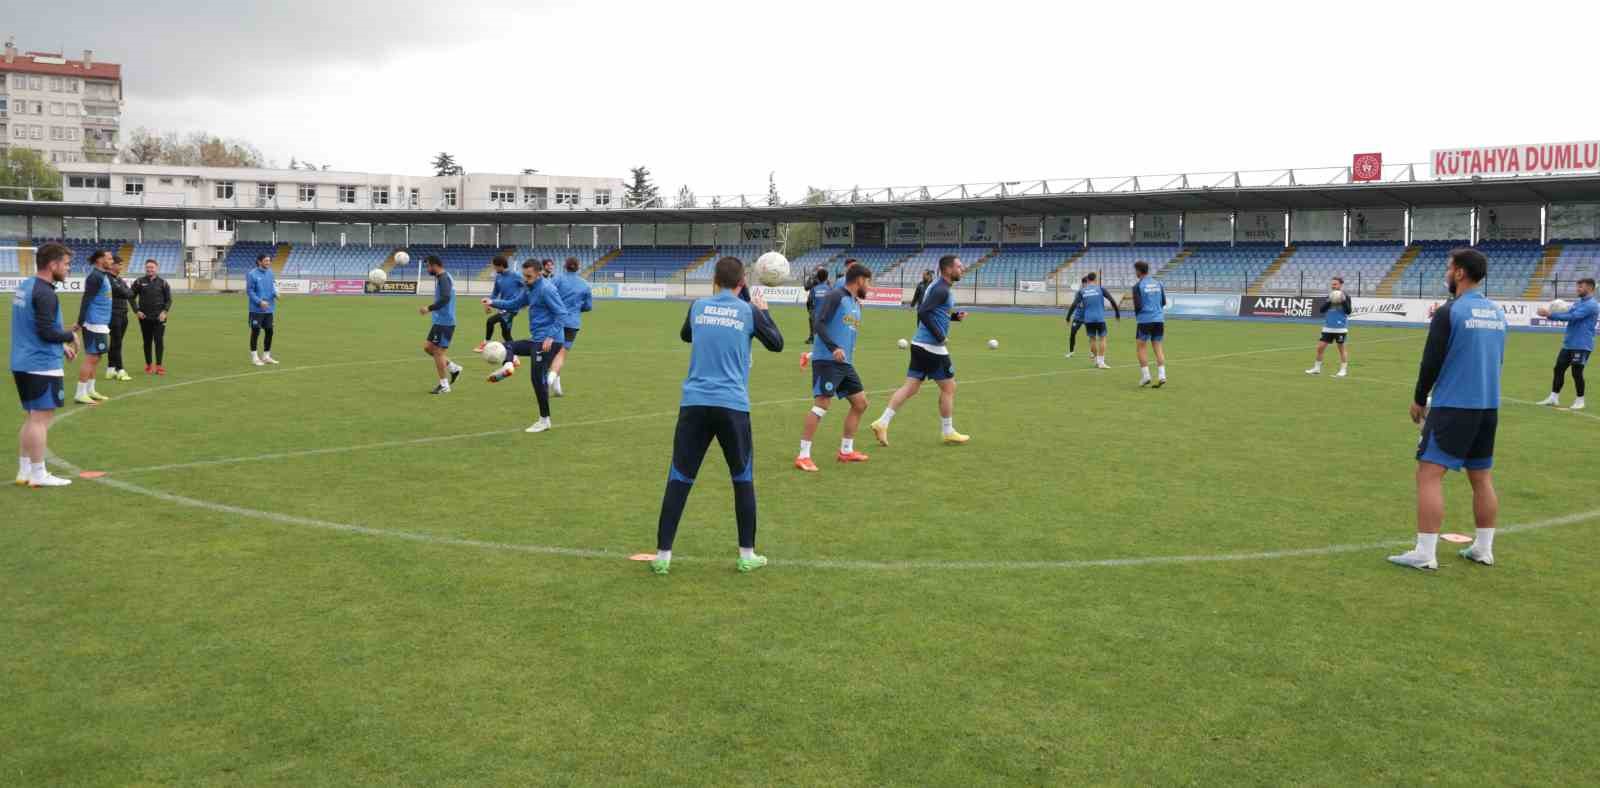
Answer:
xmin=678 ymin=290 xmax=784 ymax=412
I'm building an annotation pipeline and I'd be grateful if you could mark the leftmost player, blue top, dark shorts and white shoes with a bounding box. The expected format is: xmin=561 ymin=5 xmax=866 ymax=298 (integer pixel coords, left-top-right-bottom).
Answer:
xmin=11 ymin=243 xmax=77 ymax=487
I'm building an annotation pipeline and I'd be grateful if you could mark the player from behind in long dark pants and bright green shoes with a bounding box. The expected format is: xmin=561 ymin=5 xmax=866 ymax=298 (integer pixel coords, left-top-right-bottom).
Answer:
xmin=650 ymin=258 xmax=784 ymax=575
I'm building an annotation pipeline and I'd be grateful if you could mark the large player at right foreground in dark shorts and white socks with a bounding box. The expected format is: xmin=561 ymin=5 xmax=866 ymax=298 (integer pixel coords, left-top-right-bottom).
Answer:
xmin=1389 ymin=248 xmax=1506 ymax=569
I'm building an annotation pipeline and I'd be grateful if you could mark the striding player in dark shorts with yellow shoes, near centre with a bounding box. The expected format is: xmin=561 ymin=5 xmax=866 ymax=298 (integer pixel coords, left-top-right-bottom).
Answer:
xmin=869 ymin=255 xmax=971 ymax=445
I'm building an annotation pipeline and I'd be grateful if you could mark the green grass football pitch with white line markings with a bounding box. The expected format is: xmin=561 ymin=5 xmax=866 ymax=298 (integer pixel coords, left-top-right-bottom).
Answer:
xmin=0 ymin=296 xmax=1600 ymax=785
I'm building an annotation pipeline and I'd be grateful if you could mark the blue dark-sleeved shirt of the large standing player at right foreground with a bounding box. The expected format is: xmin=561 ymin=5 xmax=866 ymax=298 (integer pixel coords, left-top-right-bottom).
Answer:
xmin=1413 ymin=288 xmax=1506 ymax=410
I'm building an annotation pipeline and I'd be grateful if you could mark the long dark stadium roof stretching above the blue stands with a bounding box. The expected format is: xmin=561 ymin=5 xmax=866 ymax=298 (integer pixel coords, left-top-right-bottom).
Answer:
xmin=9 ymin=175 xmax=1600 ymax=224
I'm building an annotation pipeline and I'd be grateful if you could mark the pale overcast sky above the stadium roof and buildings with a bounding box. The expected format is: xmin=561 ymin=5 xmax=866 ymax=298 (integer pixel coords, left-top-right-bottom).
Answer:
xmin=12 ymin=0 xmax=1600 ymax=197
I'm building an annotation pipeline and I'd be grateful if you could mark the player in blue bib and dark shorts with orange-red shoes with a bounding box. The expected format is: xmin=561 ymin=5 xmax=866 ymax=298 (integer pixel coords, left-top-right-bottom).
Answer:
xmin=795 ymin=263 xmax=872 ymax=472
